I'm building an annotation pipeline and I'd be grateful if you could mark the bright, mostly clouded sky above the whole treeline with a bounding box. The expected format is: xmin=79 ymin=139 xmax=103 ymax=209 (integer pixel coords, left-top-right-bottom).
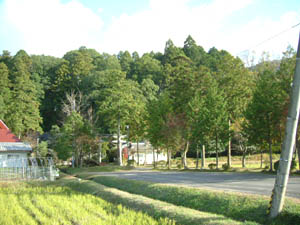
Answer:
xmin=0 ymin=0 xmax=300 ymax=61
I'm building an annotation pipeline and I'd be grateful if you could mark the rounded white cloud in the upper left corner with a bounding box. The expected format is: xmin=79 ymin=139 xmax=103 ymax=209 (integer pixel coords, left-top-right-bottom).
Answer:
xmin=3 ymin=0 xmax=103 ymax=56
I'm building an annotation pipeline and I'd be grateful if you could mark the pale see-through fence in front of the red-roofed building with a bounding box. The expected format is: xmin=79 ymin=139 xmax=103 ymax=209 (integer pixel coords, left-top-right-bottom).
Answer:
xmin=0 ymin=158 xmax=57 ymax=181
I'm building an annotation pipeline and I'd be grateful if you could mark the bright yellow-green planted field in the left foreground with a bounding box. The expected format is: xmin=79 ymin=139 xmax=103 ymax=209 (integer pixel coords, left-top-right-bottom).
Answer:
xmin=0 ymin=179 xmax=174 ymax=225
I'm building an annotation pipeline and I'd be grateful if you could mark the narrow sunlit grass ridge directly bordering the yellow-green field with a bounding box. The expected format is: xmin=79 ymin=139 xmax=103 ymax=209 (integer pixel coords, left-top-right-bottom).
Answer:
xmin=56 ymin=176 xmax=248 ymax=225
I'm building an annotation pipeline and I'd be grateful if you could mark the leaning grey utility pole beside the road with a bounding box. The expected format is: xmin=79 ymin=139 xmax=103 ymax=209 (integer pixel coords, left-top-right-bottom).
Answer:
xmin=269 ymin=34 xmax=300 ymax=218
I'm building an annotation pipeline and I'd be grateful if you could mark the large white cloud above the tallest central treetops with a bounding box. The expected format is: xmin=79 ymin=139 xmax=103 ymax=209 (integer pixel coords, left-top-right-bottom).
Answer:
xmin=103 ymin=0 xmax=252 ymax=53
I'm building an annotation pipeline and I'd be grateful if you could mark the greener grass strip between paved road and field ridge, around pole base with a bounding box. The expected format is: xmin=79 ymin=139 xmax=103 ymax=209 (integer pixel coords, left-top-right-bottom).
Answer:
xmin=81 ymin=176 xmax=300 ymax=225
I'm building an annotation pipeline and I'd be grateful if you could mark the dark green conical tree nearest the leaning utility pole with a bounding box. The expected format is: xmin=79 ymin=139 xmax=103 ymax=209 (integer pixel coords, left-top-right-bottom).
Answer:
xmin=245 ymin=67 xmax=288 ymax=171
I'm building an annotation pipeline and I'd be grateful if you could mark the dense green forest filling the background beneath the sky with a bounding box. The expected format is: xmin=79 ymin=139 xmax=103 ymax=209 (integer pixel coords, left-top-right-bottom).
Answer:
xmin=0 ymin=36 xmax=296 ymax=169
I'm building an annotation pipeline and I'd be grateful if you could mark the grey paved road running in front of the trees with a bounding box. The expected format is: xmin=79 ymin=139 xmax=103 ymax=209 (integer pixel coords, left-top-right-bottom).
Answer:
xmin=93 ymin=170 xmax=300 ymax=199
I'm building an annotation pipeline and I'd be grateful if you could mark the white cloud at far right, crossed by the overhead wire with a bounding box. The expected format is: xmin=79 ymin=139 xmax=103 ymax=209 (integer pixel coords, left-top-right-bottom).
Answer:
xmin=231 ymin=12 xmax=300 ymax=61
